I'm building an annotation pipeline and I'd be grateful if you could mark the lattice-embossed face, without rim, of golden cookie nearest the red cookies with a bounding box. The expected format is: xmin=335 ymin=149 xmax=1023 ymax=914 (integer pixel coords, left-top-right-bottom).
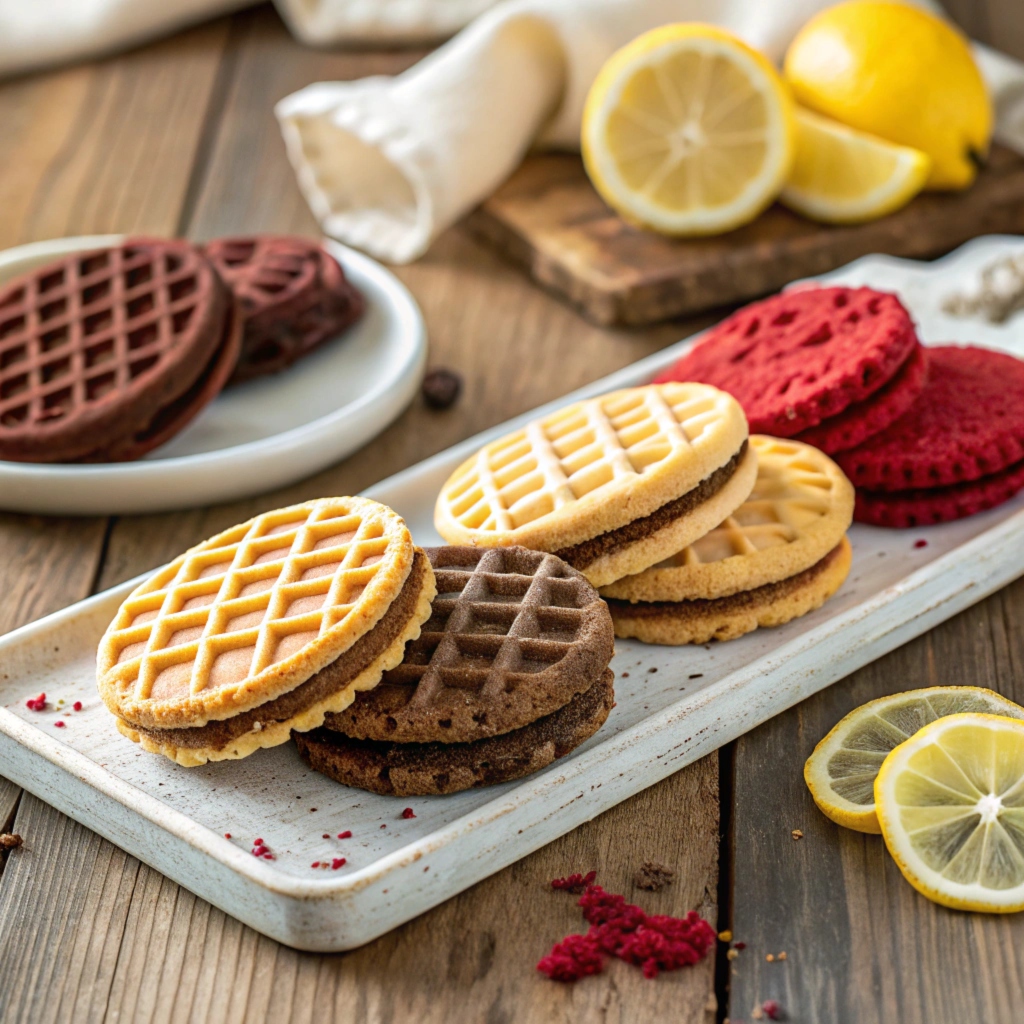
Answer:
xmin=655 ymin=434 xmax=845 ymax=568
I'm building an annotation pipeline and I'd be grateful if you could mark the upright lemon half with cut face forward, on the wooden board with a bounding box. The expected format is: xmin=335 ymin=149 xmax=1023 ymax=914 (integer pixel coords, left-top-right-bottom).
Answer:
xmin=581 ymin=24 xmax=794 ymax=234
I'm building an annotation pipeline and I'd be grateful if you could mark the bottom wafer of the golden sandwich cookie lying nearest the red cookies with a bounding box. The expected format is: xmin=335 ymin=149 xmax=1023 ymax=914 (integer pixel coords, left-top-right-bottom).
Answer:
xmin=611 ymin=538 xmax=853 ymax=647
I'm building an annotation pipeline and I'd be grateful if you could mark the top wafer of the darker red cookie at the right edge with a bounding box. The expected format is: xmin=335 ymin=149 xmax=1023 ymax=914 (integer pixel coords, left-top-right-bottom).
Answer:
xmin=837 ymin=346 xmax=1024 ymax=492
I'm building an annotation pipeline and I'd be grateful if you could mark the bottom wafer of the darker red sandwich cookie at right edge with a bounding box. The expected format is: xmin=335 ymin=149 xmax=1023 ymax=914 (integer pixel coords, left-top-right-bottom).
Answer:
xmin=853 ymin=462 xmax=1024 ymax=528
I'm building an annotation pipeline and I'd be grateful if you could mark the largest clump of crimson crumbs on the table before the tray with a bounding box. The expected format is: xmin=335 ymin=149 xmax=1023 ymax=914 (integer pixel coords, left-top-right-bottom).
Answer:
xmin=537 ymin=885 xmax=716 ymax=981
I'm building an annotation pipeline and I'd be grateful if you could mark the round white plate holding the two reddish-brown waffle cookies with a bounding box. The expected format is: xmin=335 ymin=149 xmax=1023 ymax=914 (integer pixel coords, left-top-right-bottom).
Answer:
xmin=0 ymin=234 xmax=427 ymax=515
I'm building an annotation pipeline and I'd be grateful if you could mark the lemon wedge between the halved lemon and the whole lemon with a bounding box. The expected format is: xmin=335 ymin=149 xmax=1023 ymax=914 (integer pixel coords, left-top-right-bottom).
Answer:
xmin=780 ymin=108 xmax=932 ymax=224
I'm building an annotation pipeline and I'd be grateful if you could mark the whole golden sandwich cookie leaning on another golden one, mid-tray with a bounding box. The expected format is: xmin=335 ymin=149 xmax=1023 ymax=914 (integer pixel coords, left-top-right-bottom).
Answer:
xmin=434 ymin=383 xmax=756 ymax=586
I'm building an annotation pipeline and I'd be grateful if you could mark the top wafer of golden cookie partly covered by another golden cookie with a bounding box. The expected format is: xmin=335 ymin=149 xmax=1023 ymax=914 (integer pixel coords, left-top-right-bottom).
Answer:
xmin=601 ymin=434 xmax=854 ymax=601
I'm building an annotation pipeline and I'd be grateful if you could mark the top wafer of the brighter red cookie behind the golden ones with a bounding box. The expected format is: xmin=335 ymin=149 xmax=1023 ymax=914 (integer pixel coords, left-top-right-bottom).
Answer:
xmin=657 ymin=288 xmax=918 ymax=437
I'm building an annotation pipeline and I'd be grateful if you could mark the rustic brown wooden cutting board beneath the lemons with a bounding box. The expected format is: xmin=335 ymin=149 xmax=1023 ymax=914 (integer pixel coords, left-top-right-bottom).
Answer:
xmin=468 ymin=147 xmax=1024 ymax=325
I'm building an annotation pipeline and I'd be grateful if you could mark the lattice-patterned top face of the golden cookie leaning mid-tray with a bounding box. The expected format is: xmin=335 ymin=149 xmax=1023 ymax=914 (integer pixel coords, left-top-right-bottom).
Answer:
xmin=438 ymin=384 xmax=741 ymax=540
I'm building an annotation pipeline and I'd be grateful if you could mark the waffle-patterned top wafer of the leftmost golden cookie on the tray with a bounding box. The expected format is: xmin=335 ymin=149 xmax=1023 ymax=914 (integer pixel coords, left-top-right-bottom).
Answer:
xmin=97 ymin=498 xmax=414 ymax=728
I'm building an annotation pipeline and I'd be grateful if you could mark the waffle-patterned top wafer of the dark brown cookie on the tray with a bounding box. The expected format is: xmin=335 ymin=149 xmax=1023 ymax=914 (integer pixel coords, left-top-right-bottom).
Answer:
xmin=325 ymin=547 xmax=614 ymax=742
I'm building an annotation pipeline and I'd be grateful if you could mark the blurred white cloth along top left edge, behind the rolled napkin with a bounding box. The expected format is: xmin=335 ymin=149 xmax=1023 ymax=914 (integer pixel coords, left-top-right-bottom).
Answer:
xmin=0 ymin=0 xmax=496 ymax=76
